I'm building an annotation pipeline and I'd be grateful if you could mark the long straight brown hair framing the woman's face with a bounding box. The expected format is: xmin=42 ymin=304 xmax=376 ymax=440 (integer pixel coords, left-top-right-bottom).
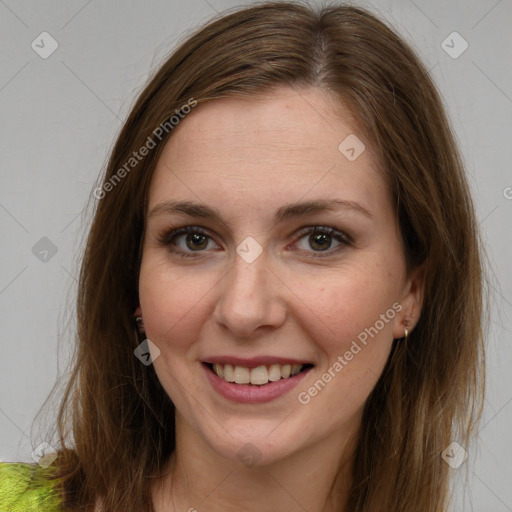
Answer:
xmin=43 ymin=2 xmax=484 ymax=512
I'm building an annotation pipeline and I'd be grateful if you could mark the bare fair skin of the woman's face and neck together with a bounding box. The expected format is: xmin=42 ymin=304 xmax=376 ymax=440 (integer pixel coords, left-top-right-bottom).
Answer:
xmin=139 ymin=88 xmax=422 ymax=512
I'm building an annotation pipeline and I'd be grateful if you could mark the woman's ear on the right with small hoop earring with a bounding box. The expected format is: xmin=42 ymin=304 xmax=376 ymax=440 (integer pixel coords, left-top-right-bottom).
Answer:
xmin=393 ymin=265 xmax=425 ymax=339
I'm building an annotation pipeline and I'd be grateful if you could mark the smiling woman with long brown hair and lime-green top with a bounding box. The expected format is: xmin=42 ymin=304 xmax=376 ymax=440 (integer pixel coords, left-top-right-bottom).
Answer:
xmin=3 ymin=3 xmax=483 ymax=512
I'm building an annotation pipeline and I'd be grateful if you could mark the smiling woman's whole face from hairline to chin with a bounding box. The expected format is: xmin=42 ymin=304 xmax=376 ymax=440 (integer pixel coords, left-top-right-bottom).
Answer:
xmin=139 ymin=88 xmax=420 ymax=463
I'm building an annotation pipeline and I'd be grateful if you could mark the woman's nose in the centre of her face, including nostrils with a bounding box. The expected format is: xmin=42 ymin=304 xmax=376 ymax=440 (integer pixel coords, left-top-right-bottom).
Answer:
xmin=213 ymin=250 xmax=286 ymax=339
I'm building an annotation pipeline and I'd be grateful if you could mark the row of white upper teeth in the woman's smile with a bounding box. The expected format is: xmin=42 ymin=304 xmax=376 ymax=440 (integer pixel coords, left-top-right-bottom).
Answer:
xmin=213 ymin=364 xmax=303 ymax=386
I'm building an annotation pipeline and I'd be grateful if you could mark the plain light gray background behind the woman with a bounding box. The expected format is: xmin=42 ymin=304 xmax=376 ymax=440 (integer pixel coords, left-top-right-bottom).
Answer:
xmin=0 ymin=0 xmax=512 ymax=512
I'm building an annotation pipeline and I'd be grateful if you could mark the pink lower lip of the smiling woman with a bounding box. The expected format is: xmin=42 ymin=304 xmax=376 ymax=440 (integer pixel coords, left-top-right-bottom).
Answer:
xmin=203 ymin=364 xmax=310 ymax=404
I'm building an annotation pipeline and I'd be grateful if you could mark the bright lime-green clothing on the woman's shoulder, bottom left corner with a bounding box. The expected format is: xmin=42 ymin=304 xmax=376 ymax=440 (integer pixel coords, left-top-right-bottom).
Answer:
xmin=0 ymin=462 xmax=62 ymax=512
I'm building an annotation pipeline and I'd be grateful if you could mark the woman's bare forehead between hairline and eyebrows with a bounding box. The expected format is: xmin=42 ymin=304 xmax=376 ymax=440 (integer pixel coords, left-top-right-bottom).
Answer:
xmin=149 ymin=88 xmax=387 ymax=214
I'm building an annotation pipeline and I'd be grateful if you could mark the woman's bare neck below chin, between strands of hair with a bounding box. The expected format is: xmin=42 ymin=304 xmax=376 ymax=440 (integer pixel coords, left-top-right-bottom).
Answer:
xmin=153 ymin=421 xmax=355 ymax=512
